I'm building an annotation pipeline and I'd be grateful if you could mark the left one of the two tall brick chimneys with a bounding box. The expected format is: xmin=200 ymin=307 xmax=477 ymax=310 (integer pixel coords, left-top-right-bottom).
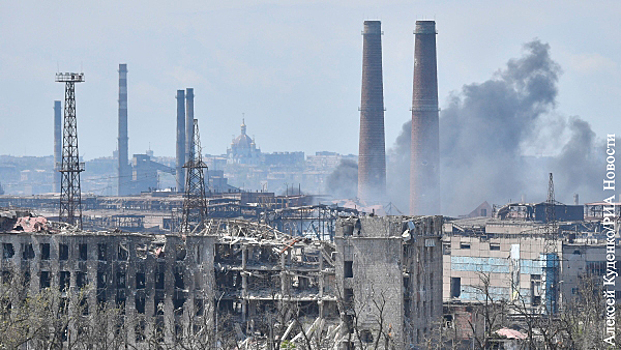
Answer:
xmin=358 ymin=21 xmax=386 ymax=201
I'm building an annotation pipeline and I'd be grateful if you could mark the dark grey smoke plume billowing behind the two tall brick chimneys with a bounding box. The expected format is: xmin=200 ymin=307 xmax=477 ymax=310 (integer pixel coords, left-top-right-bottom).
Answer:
xmin=388 ymin=39 xmax=602 ymax=215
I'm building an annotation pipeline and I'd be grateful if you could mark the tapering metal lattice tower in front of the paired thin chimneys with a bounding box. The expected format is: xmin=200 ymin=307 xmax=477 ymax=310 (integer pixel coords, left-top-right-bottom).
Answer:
xmin=180 ymin=119 xmax=207 ymax=233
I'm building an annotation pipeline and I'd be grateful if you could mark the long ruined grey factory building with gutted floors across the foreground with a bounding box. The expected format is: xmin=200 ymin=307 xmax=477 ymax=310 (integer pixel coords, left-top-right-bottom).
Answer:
xmin=0 ymin=211 xmax=442 ymax=349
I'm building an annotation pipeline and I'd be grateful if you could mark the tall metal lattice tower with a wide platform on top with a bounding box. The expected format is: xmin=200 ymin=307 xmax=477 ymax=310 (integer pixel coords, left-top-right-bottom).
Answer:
xmin=56 ymin=73 xmax=84 ymax=229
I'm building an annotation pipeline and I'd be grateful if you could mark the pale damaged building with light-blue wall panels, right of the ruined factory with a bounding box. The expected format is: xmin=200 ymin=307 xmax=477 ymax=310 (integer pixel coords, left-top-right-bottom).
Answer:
xmin=443 ymin=213 xmax=621 ymax=343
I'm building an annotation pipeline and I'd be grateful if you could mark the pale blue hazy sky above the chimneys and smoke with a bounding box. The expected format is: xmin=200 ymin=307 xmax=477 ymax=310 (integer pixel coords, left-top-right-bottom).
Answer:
xmin=0 ymin=0 xmax=621 ymax=159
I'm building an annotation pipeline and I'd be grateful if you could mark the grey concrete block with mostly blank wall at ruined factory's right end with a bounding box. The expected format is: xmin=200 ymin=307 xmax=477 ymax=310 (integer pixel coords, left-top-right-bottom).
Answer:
xmin=335 ymin=216 xmax=442 ymax=349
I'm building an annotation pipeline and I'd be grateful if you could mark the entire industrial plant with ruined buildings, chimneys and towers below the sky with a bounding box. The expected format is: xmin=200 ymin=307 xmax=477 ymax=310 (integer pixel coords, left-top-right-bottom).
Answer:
xmin=0 ymin=20 xmax=621 ymax=350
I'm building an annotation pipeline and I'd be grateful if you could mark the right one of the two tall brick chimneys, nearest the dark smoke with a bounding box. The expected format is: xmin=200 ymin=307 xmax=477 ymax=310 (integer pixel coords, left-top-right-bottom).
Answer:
xmin=410 ymin=21 xmax=440 ymax=215
